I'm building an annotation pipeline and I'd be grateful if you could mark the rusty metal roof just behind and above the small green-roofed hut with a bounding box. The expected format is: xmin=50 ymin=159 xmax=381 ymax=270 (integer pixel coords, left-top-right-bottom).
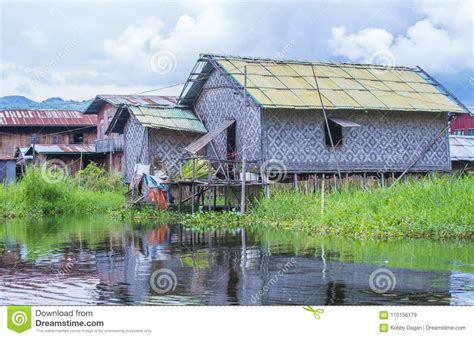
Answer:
xmin=84 ymin=95 xmax=177 ymax=114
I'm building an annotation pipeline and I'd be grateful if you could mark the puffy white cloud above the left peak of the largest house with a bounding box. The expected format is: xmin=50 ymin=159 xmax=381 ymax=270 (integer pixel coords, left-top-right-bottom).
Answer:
xmin=99 ymin=5 xmax=236 ymax=84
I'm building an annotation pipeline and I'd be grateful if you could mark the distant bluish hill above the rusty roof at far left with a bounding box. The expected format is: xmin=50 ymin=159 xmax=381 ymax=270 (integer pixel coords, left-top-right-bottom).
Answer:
xmin=0 ymin=95 xmax=92 ymax=111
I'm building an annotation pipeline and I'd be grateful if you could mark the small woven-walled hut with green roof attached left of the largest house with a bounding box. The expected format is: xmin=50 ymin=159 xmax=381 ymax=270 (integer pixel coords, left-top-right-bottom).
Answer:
xmin=105 ymin=103 xmax=207 ymax=183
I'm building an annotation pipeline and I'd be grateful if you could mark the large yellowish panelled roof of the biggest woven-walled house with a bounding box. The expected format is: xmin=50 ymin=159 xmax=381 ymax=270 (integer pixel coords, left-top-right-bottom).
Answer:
xmin=178 ymin=55 xmax=466 ymax=113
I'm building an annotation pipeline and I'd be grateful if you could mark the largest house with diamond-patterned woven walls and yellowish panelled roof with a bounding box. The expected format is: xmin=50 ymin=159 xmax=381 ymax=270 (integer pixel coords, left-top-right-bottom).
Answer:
xmin=178 ymin=54 xmax=468 ymax=174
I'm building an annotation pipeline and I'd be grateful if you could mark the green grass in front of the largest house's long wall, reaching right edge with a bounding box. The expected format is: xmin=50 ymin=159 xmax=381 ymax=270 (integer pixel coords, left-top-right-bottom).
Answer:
xmin=184 ymin=175 xmax=474 ymax=239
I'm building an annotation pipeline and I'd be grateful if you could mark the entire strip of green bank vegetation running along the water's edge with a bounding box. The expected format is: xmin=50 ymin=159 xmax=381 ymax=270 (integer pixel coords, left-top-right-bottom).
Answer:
xmin=0 ymin=164 xmax=474 ymax=239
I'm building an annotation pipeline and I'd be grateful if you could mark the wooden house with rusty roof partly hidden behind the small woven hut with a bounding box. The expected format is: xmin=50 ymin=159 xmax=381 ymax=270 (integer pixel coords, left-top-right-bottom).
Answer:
xmin=84 ymin=94 xmax=176 ymax=172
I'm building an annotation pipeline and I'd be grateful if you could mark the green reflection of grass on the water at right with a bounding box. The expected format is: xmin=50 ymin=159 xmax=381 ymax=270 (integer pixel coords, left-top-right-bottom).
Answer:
xmin=249 ymin=227 xmax=474 ymax=273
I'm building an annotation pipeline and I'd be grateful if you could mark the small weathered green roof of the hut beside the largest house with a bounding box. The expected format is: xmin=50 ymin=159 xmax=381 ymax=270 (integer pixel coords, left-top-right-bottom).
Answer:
xmin=107 ymin=105 xmax=207 ymax=134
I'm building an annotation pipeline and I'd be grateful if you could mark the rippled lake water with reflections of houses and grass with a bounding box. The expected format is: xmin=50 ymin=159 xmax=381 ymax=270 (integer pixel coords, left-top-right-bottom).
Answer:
xmin=0 ymin=218 xmax=474 ymax=305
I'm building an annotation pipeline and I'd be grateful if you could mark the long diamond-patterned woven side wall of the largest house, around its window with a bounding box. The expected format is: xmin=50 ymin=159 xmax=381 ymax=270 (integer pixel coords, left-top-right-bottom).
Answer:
xmin=263 ymin=110 xmax=450 ymax=171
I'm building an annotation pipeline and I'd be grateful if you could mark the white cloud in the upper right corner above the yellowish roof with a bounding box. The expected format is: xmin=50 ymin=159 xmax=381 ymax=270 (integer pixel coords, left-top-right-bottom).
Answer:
xmin=329 ymin=0 xmax=474 ymax=73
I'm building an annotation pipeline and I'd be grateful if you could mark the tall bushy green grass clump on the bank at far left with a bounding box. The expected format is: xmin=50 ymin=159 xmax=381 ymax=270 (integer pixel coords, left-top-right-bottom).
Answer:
xmin=0 ymin=164 xmax=125 ymax=217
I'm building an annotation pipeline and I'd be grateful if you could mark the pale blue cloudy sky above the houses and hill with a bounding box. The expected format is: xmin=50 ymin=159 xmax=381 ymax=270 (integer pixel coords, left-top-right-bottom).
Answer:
xmin=0 ymin=0 xmax=474 ymax=106
